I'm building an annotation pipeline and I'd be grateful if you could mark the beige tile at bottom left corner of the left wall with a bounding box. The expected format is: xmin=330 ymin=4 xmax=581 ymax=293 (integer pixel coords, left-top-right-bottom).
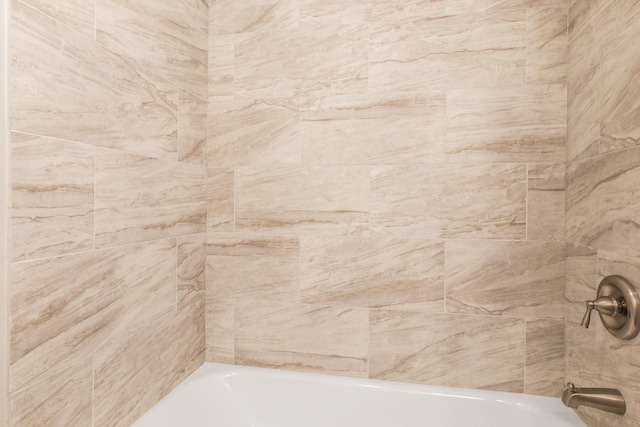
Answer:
xmin=8 ymin=359 xmax=93 ymax=427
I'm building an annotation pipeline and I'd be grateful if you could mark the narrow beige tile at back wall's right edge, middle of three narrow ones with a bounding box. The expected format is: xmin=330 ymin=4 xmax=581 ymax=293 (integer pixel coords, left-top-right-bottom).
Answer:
xmin=527 ymin=163 xmax=566 ymax=242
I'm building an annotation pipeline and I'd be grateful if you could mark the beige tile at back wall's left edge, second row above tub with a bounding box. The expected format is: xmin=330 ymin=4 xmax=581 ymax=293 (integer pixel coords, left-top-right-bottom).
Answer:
xmin=207 ymin=233 xmax=300 ymax=302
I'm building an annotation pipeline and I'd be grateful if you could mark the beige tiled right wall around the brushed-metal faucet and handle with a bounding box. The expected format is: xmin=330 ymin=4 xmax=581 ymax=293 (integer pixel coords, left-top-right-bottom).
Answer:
xmin=566 ymin=0 xmax=640 ymax=427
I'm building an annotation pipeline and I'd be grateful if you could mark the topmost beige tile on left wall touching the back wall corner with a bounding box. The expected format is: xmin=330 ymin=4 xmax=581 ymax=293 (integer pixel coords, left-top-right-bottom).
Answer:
xmin=96 ymin=0 xmax=209 ymax=97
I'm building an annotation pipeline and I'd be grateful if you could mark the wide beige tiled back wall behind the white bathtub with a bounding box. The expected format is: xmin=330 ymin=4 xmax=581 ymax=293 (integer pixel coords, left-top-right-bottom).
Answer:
xmin=206 ymin=0 xmax=568 ymax=395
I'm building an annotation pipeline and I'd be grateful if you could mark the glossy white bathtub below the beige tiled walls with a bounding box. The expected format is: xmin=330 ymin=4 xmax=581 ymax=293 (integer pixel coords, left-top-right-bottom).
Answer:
xmin=134 ymin=363 xmax=585 ymax=427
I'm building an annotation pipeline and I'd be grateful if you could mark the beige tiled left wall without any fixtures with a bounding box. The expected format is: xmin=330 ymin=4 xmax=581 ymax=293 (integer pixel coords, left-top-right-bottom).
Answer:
xmin=6 ymin=0 xmax=208 ymax=427
